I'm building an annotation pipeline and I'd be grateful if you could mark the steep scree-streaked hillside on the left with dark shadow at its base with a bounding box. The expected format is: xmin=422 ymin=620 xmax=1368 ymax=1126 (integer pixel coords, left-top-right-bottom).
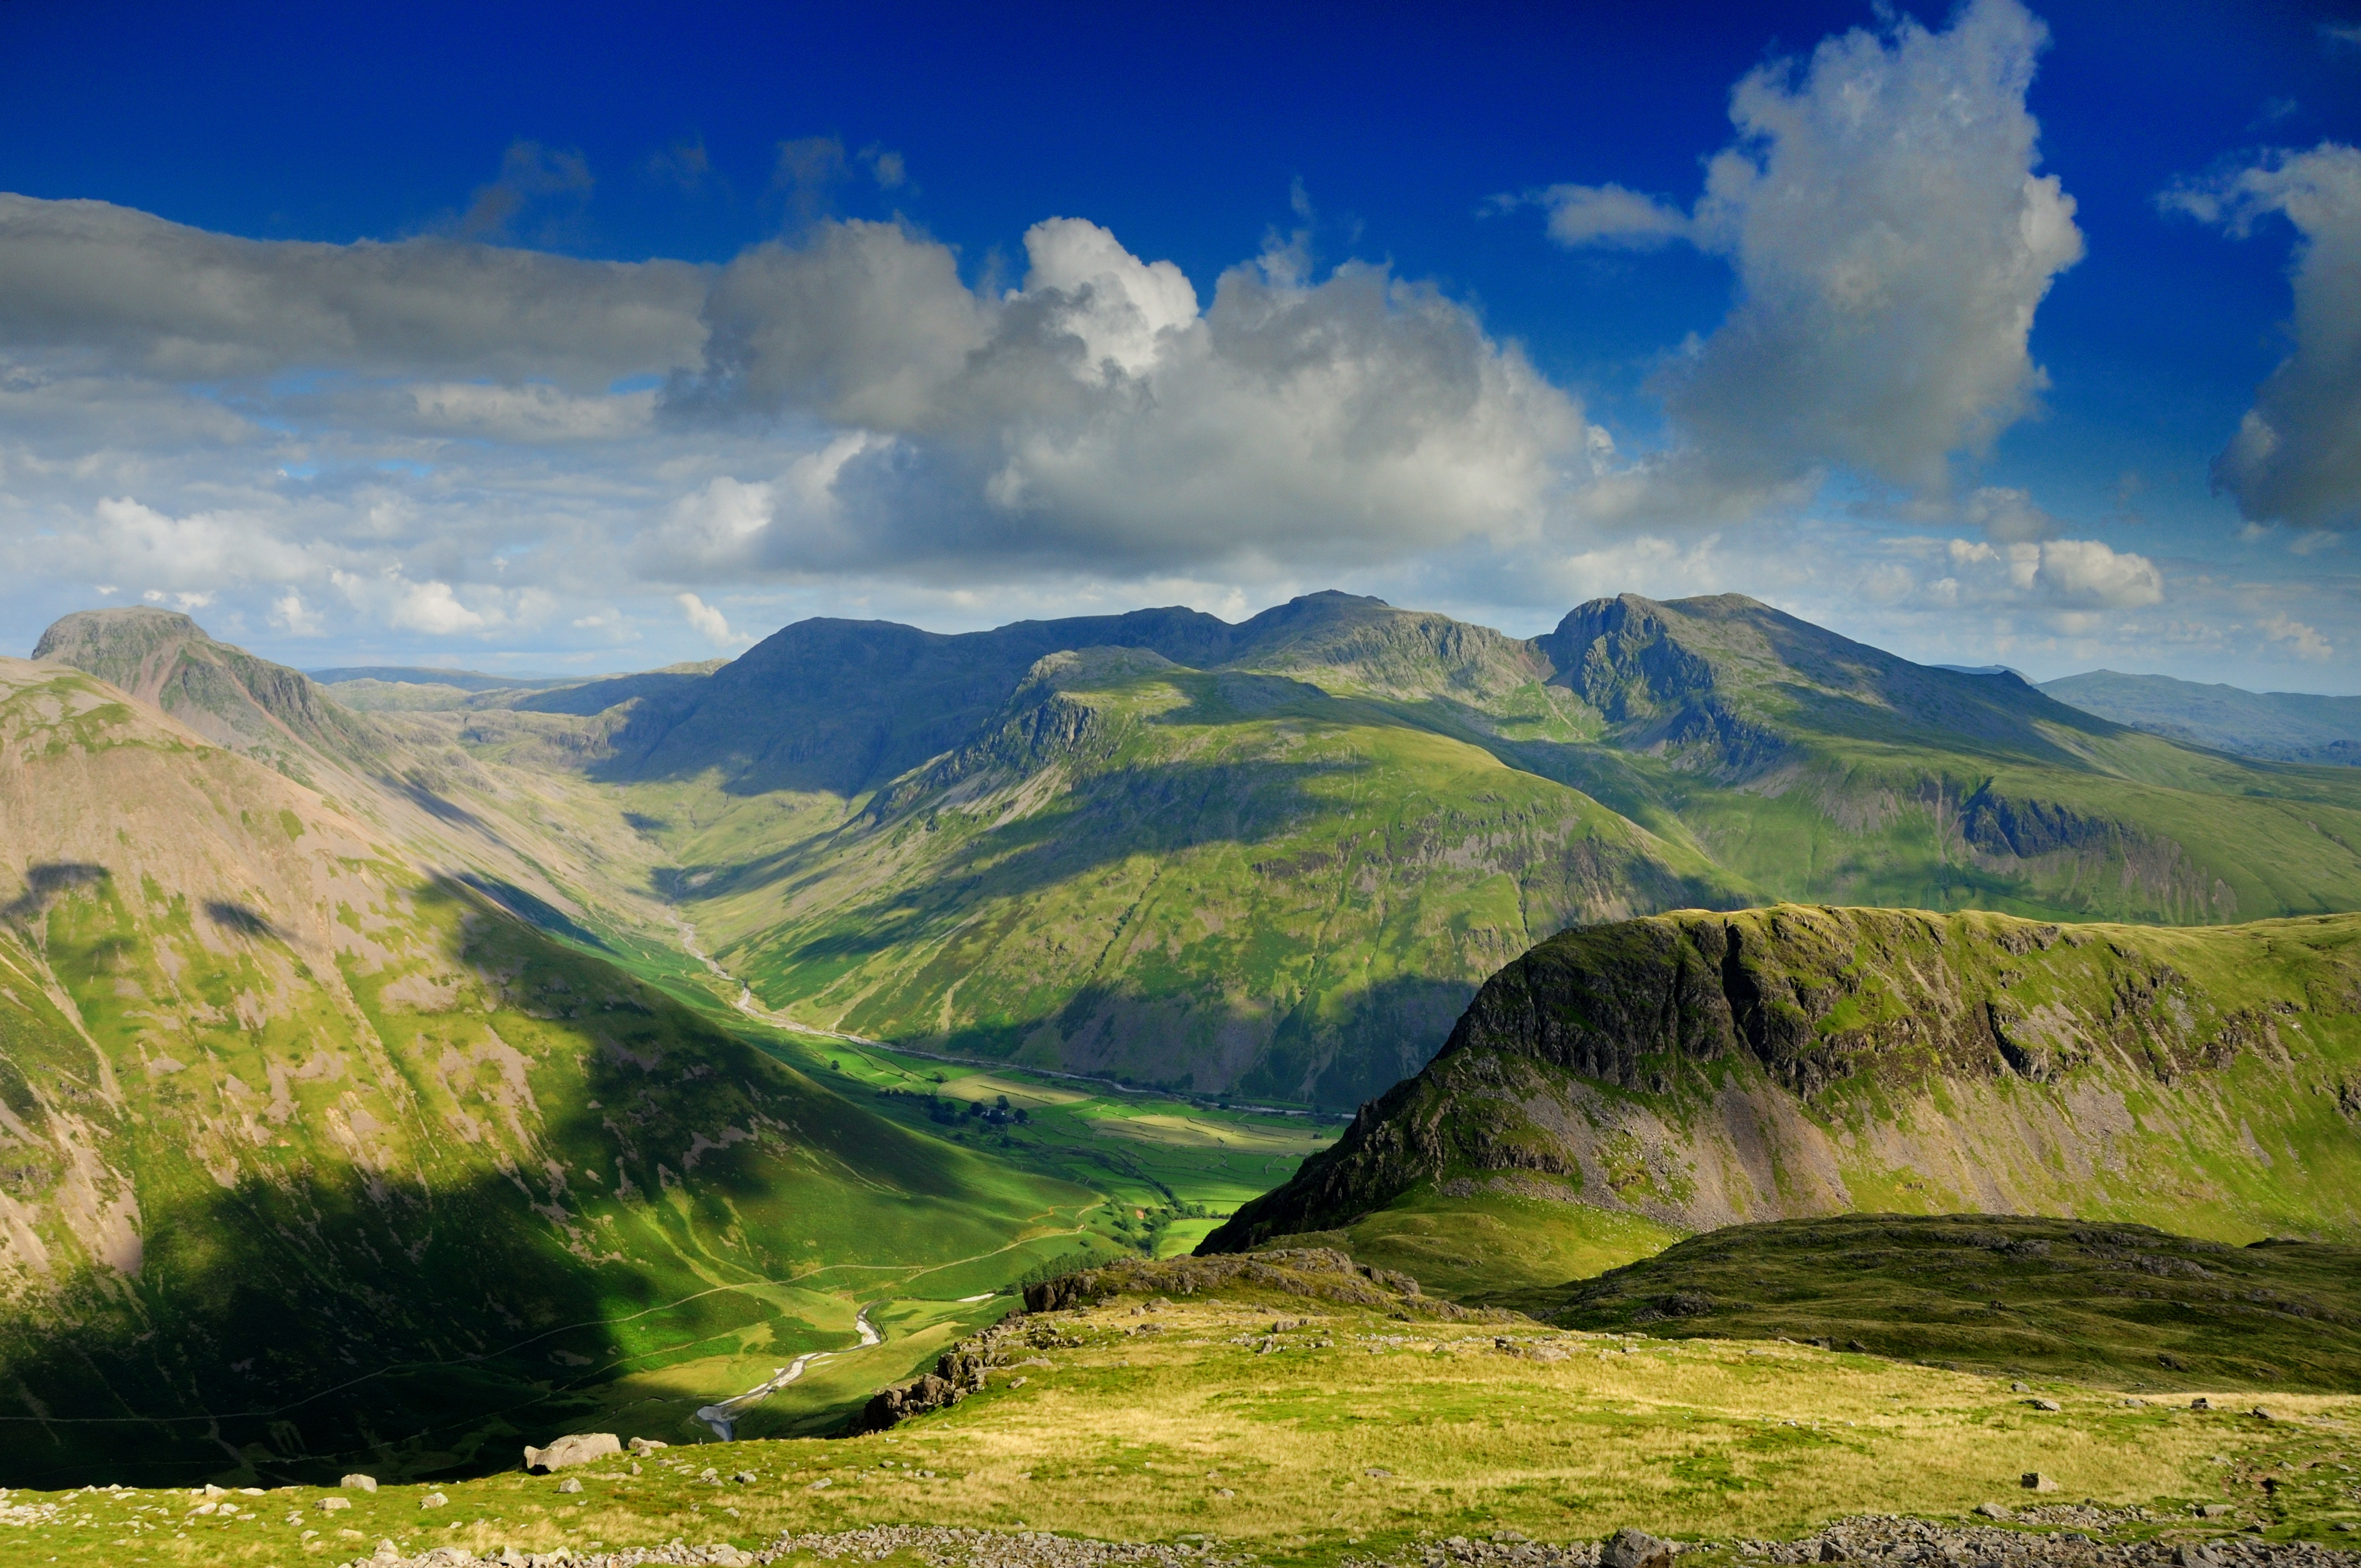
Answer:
xmin=0 ymin=661 xmax=1093 ymax=1485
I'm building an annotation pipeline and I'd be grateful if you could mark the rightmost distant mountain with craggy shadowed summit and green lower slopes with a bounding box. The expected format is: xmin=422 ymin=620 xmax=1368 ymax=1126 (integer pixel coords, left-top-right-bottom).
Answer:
xmin=1518 ymin=595 xmax=2361 ymax=923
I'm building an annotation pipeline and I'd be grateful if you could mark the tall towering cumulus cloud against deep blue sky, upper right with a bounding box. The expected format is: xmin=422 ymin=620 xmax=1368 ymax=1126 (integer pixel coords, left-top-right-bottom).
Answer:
xmin=1539 ymin=0 xmax=2082 ymax=494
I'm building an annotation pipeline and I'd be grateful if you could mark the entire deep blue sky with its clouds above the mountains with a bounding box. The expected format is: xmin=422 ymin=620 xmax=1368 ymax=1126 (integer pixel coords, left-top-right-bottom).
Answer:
xmin=0 ymin=2 xmax=2361 ymax=692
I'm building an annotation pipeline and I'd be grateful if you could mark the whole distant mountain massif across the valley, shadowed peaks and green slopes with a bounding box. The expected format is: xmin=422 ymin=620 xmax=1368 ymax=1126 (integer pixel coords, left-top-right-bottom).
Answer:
xmin=32 ymin=593 xmax=2361 ymax=1105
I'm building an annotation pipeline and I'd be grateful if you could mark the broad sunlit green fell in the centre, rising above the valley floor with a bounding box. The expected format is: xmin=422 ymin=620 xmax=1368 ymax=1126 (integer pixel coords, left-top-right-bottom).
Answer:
xmin=666 ymin=650 xmax=1745 ymax=1105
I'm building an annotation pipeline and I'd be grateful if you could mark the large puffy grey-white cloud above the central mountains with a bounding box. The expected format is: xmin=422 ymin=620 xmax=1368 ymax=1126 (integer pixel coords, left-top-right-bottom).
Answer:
xmin=647 ymin=217 xmax=1591 ymax=572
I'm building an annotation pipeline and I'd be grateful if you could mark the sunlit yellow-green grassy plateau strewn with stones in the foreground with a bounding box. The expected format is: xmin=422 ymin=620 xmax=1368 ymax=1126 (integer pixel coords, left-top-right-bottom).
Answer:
xmin=0 ymin=1254 xmax=2361 ymax=1563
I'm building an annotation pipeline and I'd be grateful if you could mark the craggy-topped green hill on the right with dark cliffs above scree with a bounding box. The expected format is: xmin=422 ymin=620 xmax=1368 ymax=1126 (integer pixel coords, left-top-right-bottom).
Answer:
xmin=1207 ymin=904 xmax=2361 ymax=1285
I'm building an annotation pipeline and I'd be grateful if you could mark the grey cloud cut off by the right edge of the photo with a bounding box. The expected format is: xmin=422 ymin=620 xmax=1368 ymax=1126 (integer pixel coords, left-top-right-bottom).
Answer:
xmin=2165 ymin=142 xmax=2361 ymax=529
